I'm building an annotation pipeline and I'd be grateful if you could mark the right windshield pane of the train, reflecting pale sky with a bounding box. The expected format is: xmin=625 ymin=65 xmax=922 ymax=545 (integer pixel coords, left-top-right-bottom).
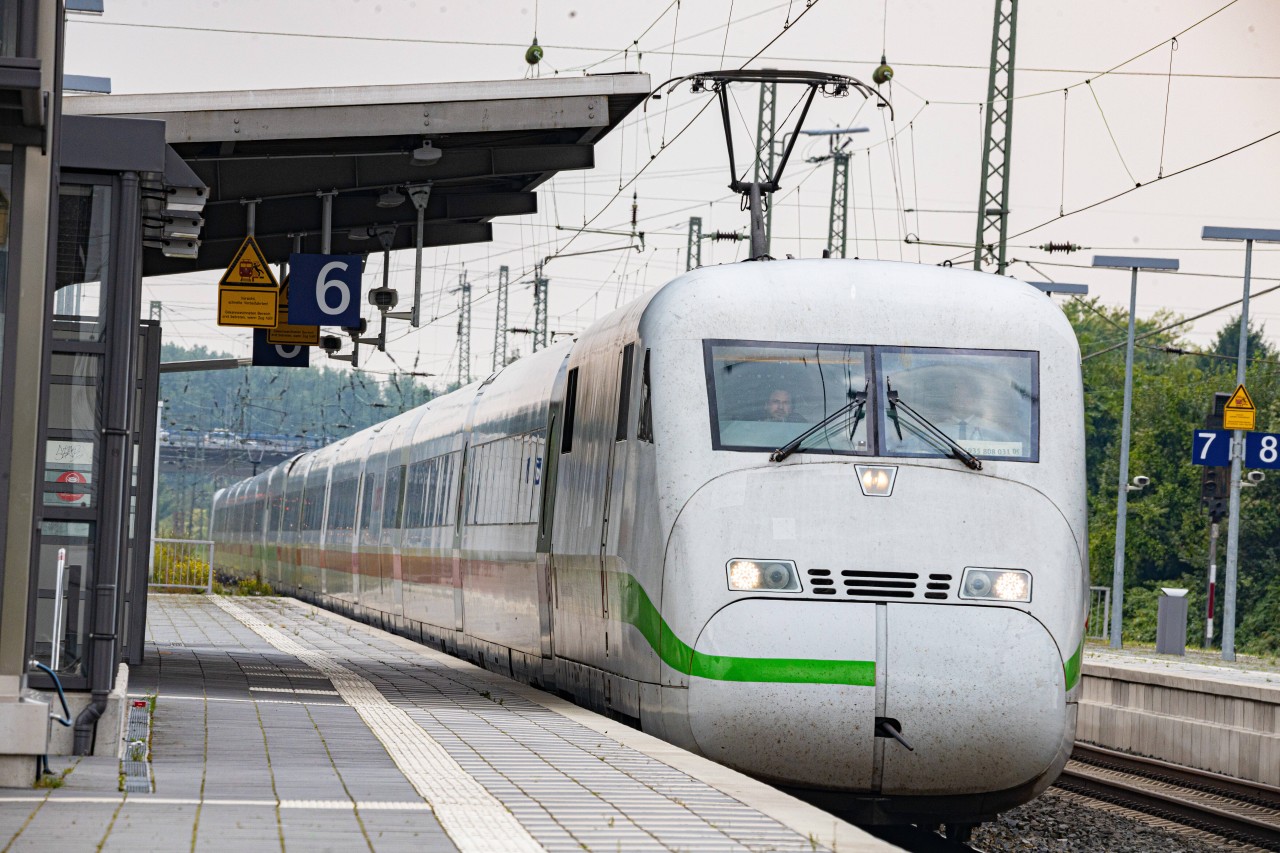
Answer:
xmin=878 ymin=350 xmax=1039 ymax=462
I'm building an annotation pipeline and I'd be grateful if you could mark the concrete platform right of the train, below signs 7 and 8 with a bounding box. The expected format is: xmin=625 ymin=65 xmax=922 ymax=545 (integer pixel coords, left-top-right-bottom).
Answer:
xmin=1076 ymin=648 xmax=1280 ymax=786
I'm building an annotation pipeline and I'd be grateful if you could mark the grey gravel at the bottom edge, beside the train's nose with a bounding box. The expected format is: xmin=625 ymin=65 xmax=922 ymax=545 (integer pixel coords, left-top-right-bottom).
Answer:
xmin=970 ymin=789 xmax=1257 ymax=853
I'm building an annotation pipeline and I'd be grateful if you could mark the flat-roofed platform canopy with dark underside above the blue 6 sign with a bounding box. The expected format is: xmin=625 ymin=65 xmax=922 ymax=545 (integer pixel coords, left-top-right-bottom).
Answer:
xmin=64 ymin=74 xmax=649 ymax=275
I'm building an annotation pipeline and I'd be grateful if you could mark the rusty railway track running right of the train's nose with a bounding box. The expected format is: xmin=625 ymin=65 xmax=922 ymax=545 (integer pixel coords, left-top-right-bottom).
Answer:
xmin=1056 ymin=743 xmax=1280 ymax=850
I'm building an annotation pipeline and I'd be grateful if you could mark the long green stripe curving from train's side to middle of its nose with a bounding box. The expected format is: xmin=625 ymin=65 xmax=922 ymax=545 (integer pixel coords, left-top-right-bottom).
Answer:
xmin=609 ymin=573 xmax=876 ymax=686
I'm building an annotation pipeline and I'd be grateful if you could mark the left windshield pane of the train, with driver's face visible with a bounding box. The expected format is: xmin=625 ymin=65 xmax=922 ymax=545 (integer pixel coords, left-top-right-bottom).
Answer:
xmin=707 ymin=341 xmax=869 ymax=453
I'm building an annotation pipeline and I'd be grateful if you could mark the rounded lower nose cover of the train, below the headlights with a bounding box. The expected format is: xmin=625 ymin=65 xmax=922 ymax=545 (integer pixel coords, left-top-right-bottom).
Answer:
xmin=689 ymin=599 xmax=1071 ymax=797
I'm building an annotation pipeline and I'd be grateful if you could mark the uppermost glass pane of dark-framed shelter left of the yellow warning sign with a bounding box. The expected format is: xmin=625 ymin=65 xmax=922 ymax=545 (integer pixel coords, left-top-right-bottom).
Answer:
xmin=54 ymin=183 xmax=111 ymax=341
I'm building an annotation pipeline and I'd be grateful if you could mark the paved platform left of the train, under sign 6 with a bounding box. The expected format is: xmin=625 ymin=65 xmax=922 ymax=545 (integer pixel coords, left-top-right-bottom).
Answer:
xmin=0 ymin=596 xmax=897 ymax=853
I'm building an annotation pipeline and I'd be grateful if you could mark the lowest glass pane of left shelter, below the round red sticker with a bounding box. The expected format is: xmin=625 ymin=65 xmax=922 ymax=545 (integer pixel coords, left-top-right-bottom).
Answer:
xmin=35 ymin=521 xmax=93 ymax=676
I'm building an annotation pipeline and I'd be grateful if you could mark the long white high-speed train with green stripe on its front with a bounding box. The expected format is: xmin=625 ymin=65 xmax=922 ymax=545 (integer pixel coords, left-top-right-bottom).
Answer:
xmin=214 ymin=260 xmax=1088 ymax=827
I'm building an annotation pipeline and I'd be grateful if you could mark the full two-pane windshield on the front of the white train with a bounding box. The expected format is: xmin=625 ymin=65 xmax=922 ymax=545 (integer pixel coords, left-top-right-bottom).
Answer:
xmin=703 ymin=339 xmax=1039 ymax=462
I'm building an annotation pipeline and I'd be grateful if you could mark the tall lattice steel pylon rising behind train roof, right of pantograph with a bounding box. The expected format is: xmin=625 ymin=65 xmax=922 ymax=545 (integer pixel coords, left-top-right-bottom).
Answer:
xmin=973 ymin=0 xmax=1018 ymax=275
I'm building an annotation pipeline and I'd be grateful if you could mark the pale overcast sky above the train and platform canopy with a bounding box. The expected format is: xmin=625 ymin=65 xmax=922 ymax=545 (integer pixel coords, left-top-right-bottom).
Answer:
xmin=65 ymin=0 xmax=1280 ymax=389
